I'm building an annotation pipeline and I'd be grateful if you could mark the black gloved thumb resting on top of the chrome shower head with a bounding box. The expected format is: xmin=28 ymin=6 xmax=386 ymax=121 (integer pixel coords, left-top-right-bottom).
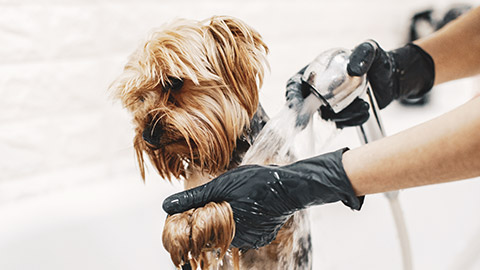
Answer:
xmin=347 ymin=40 xmax=379 ymax=76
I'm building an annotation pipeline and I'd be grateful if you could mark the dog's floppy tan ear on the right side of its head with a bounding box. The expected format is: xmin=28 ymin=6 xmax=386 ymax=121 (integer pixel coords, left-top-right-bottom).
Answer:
xmin=203 ymin=16 xmax=268 ymax=117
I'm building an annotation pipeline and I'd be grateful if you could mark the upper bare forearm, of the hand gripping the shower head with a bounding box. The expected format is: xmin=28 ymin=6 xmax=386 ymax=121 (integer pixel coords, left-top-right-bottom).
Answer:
xmin=414 ymin=7 xmax=480 ymax=84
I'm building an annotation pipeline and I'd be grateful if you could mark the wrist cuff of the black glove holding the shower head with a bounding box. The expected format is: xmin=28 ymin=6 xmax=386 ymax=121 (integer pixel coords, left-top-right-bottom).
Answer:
xmin=391 ymin=43 xmax=435 ymax=99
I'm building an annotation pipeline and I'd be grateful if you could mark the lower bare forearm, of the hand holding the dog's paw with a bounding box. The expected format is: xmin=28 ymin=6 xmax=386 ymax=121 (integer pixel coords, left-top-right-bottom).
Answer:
xmin=343 ymin=98 xmax=480 ymax=195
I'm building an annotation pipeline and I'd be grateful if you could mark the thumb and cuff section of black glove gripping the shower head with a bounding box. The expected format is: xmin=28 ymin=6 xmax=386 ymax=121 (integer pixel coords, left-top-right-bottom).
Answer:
xmin=347 ymin=40 xmax=435 ymax=109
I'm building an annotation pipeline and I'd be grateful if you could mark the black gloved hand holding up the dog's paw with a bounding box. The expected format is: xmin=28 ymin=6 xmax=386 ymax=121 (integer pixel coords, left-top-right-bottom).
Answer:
xmin=163 ymin=149 xmax=363 ymax=249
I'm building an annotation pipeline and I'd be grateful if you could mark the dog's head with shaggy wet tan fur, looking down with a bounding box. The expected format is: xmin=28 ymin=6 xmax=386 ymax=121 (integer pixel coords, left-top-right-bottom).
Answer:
xmin=111 ymin=17 xmax=268 ymax=179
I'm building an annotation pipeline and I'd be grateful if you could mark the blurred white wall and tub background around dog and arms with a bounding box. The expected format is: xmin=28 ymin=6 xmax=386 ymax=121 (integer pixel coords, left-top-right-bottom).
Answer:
xmin=0 ymin=0 xmax=480 ymax=270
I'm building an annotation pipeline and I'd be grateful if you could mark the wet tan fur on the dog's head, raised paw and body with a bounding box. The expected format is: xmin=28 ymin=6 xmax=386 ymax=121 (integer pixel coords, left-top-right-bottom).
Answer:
xmin=111 ymin=17 xmax=308 ymax=269
